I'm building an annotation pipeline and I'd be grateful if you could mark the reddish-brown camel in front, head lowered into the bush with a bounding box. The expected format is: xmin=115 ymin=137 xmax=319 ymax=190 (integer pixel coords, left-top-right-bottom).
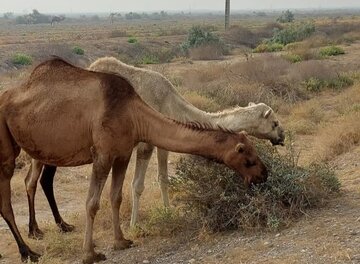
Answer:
xmin=0 ymin=58 xmax=267 ymax=263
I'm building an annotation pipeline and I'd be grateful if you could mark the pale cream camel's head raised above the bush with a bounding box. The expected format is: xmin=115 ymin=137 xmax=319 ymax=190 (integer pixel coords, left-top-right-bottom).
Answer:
xmin=248 ymin=103 xmax=285 ymax=146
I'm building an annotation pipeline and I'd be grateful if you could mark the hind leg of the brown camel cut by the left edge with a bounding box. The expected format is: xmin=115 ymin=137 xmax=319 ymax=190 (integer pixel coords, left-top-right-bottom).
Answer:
xmin=0 ymin=123 xmax=40 ymax=261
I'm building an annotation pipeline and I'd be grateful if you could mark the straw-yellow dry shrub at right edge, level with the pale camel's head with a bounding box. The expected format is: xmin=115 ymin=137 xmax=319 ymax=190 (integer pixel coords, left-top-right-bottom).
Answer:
xmin=316 ymin=111 xmax=360 ymax=161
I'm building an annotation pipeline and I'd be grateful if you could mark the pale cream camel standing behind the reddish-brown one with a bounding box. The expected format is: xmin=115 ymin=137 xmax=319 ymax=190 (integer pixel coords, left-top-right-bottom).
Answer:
xmin=25 ymin=57 xmax=285 ymax=238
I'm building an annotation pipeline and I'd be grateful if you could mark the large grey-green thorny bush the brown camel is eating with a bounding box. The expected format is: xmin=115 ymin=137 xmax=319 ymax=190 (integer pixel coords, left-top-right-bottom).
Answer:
xmin=171 ymin=136 xmax=340 ymax=232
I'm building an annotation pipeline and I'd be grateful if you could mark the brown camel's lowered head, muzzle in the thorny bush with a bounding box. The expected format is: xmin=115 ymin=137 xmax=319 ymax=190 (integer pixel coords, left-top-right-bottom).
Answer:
xmin=223 ymin=132 xmax=267 ymax=186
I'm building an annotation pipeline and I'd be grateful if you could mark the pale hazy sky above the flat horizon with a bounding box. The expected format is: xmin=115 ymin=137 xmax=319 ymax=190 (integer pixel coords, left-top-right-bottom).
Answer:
xmin=0 ymin=0 xmax=360 ymax=13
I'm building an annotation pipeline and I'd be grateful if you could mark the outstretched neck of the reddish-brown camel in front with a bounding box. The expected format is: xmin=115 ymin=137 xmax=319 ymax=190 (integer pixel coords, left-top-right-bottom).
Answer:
xmin=134 ymin=100 xmax=231 ymax=161
